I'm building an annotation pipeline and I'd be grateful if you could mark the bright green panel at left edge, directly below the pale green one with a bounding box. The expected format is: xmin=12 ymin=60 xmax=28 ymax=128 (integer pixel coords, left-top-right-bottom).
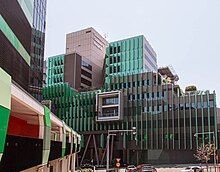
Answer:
xmin=0 ymin=105 xmax=10 ymax=160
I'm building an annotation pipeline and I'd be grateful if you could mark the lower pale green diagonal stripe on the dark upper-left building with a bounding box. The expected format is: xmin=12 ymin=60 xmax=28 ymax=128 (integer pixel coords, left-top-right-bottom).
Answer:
xmin=0 ymin=15 xmax=31 ymax=66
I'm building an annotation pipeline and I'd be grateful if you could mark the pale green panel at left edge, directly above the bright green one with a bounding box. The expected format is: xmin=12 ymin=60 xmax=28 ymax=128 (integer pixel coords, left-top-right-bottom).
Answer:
xmin=0 ymin=68 xmax=11 ymax=109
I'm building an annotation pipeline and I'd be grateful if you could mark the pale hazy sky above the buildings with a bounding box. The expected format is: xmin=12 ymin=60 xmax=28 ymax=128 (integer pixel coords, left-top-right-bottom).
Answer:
xmin=45 ymin=0 xmax=220 ymax=107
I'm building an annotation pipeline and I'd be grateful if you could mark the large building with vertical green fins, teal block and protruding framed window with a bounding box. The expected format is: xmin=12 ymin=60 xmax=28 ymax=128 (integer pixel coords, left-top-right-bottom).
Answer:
xmin=43 ymin=36 xmax=219 ymax=164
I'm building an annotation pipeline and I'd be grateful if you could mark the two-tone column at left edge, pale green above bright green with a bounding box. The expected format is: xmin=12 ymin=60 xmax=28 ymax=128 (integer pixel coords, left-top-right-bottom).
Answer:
xmin=0 ymin=68 xmax=11 ymax=161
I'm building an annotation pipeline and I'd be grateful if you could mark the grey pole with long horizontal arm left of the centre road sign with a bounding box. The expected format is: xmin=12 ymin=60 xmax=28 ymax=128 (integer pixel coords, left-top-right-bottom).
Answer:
xmin=106 ymin=127 xmax=137 ymax=171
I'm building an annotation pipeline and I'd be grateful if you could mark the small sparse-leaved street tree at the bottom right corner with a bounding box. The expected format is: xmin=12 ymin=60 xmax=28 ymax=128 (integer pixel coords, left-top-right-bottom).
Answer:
xmin=194 ymin=143 xmax=216 ymax=171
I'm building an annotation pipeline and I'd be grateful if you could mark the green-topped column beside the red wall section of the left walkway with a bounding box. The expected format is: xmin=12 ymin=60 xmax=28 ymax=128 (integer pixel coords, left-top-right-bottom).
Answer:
xmin=42 ymin=106 xmax=51 ymax=164
